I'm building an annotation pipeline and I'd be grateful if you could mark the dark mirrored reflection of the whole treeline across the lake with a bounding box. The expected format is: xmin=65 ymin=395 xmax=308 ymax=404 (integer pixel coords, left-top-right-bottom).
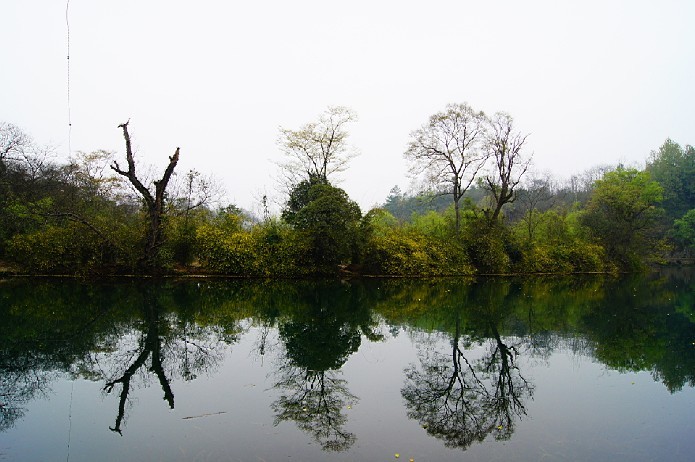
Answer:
xmin=0 ymin=275 xmax=695 ymax=450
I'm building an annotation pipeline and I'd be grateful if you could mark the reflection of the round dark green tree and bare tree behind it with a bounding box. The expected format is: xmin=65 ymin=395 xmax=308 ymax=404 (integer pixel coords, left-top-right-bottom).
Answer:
xmin=272 ymin=287 xmax=380 ymax=451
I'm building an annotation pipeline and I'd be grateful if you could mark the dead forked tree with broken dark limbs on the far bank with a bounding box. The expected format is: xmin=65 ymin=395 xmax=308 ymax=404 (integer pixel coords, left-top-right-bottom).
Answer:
xmin=111 ymin=121 xmax=179 ymax=270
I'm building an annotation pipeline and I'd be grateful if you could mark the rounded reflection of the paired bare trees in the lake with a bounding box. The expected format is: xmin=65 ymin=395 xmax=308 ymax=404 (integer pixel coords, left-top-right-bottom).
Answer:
xmin=401 ymin=316 xmax=533 ymax=449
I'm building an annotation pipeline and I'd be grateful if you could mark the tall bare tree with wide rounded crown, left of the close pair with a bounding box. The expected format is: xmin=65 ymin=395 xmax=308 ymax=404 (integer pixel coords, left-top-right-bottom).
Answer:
xmin=405 ymin=103 xmax=487 ymax=232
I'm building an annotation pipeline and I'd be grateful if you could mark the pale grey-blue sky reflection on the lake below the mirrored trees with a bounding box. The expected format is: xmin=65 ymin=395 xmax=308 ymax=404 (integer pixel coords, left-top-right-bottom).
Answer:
xmin=5 ymin=328 xmax=695 ymax=461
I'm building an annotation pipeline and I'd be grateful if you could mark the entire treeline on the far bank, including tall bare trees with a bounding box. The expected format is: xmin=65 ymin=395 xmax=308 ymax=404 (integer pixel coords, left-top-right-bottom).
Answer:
xmin=0 ymin=104 xmax=695 ymax=278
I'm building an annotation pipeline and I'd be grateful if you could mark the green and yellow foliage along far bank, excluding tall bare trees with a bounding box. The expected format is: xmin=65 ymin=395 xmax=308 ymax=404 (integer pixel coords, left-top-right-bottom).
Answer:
xmin=0 ymin=122 xmax=695 ymax=277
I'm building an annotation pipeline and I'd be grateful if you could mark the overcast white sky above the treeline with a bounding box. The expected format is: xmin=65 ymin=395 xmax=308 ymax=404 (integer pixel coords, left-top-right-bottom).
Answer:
xmin=0 ymin=0 xmax=695 ymax=209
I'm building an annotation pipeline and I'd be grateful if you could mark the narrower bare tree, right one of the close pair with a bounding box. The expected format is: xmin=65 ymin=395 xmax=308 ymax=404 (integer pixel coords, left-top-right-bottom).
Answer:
xmin=484 ymin=112 xmax=531 ymax=221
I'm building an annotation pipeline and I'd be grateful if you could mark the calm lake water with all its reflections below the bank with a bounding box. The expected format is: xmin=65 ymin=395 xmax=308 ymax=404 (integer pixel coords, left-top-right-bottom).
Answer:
xmin=0 ymin=270 xmax=695 ymax=462
